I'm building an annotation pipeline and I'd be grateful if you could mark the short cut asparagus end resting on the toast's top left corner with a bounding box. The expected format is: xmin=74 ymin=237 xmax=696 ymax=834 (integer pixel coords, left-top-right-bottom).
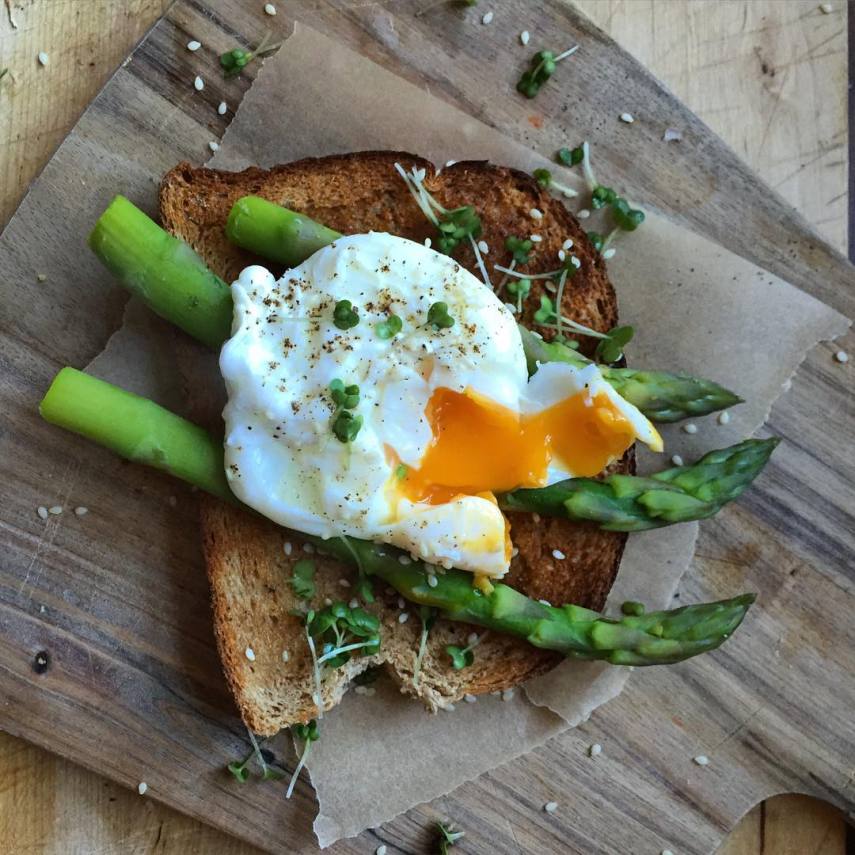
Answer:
xmin=231 ymin=196 xmax=341 ymax=267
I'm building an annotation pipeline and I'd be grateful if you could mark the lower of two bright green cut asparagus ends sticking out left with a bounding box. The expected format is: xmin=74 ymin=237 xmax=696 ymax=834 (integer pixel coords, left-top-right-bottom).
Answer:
xmin=39 ymin=368 xmax=235 ymax=502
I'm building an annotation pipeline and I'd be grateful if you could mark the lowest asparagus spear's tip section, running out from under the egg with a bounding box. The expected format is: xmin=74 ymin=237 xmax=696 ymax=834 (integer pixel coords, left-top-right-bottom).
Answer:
xmin=304 ymin=535 xmax=754 ymax=665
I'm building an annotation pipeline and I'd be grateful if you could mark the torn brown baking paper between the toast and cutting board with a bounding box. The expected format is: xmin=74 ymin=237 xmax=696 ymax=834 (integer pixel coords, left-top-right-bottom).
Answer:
xmin=87 ymin=26 xmax=847 ymax=846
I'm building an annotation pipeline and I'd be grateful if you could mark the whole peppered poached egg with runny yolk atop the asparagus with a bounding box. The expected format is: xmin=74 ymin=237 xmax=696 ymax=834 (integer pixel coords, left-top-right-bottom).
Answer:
xmin=220 ymin=232 xmax=662 ymax=577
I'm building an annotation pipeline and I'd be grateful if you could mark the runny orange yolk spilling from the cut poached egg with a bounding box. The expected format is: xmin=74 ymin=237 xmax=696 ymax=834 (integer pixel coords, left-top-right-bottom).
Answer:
xmin=399 ymin=388 xmax=635 ymax=504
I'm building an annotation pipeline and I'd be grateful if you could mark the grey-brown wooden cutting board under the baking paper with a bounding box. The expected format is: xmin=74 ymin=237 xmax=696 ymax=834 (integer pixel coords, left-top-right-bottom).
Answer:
xmin=0 ymin=2 xmax=855 ymax=852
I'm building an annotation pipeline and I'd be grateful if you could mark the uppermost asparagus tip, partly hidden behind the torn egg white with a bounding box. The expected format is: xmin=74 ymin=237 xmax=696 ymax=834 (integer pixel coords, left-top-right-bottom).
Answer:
xmin=519 ymin=325 xmax=742 ymax=422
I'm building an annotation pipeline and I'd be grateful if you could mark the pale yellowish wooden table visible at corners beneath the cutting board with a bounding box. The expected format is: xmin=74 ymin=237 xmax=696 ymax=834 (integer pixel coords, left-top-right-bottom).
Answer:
xmin=0 ymin=0 xmax=851 ymax=855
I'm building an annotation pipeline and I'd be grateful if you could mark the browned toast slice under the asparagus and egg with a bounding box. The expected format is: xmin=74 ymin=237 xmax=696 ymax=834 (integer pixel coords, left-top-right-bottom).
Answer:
xmin=160 ymin=152 xmax=634 ymax=735
